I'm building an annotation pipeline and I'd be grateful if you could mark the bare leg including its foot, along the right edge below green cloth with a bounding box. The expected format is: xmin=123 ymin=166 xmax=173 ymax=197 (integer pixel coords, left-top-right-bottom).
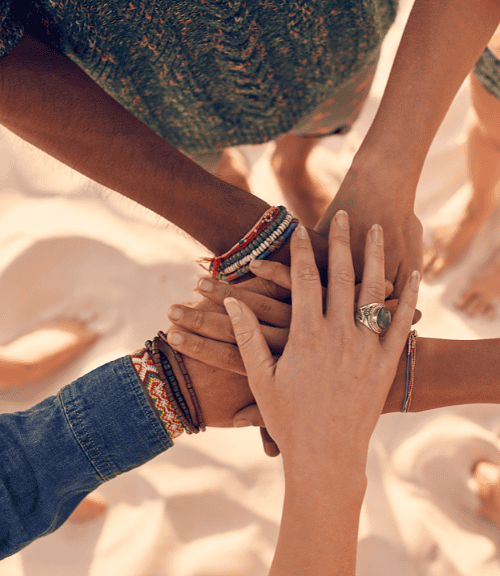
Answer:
xmin=424 ymin=74 xmax=500 ymax=280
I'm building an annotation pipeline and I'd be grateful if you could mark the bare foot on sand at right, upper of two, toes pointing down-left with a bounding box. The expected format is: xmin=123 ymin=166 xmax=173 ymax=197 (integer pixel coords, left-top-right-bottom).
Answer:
xmin=424 ymin=199 xmax=496 ymax=281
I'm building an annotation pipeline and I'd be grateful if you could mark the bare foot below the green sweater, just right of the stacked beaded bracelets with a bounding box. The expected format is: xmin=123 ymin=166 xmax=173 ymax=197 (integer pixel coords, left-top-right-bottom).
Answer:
xmin=271 ymin=134 xmax=332 ymax=228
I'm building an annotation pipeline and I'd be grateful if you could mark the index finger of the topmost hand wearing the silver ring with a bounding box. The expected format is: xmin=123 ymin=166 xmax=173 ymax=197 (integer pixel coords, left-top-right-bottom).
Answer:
xmin=290 ymin=225 xmax=323 ymax=330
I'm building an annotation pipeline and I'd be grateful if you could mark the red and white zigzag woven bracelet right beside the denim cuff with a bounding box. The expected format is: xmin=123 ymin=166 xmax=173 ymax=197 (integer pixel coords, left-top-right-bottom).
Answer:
xmin=130 ymin=348 xmax=184 ymax=440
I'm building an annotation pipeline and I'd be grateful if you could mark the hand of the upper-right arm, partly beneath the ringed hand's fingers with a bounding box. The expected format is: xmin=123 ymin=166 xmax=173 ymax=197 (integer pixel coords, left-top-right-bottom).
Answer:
xmin=316 ymin=168 xmax=423 ymax=298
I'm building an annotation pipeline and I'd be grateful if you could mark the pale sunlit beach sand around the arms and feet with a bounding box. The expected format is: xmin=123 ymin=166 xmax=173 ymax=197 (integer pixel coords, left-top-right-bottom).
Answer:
xmin=0 ymin=2 xmax=500 ymax=576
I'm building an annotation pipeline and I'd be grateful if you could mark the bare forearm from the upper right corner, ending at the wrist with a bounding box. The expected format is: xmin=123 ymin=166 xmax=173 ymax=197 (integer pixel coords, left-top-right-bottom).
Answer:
xmin=355 ymin=0 xmax=500 ymax=194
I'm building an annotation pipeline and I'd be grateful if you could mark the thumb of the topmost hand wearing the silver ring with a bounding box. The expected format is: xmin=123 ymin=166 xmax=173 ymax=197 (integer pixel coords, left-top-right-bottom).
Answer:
xmin=224 ymin=298 xmax=276 ymax=388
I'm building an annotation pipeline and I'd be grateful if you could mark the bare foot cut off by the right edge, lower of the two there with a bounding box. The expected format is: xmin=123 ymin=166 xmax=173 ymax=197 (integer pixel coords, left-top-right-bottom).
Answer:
xmin=455 ymin=247 xmax=500 ymax=319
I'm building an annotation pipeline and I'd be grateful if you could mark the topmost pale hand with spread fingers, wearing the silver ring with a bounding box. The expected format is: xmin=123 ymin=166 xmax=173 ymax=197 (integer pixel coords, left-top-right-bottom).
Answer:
xmin=225 ymin=212 xmax=419 ymax=474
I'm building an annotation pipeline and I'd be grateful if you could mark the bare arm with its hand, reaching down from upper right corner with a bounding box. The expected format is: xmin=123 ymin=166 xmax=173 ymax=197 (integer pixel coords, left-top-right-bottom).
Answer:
xmin=317 ymin=0 xmax=500 ymax=297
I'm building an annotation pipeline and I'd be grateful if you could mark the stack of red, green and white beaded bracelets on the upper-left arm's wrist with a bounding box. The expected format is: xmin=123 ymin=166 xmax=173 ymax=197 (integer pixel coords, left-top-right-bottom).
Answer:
xmin=202 ymin=206 xmax=296 ymax=282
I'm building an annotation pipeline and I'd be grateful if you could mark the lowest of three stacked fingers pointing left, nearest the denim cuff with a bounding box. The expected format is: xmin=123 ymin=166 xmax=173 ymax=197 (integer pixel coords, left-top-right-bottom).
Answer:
xmin=167 ymin=328 xmax=246 ymax=376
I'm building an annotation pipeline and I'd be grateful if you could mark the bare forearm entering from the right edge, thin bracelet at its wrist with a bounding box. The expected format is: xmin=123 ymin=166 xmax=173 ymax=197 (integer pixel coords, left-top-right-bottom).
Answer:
xmin=384 ymin=338 xmax=500 ymax=412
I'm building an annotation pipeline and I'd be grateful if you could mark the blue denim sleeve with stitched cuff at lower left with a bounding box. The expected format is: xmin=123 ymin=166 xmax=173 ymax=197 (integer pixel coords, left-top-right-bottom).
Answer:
xmin=0 ymin=357 xmax=172 ymax=559
